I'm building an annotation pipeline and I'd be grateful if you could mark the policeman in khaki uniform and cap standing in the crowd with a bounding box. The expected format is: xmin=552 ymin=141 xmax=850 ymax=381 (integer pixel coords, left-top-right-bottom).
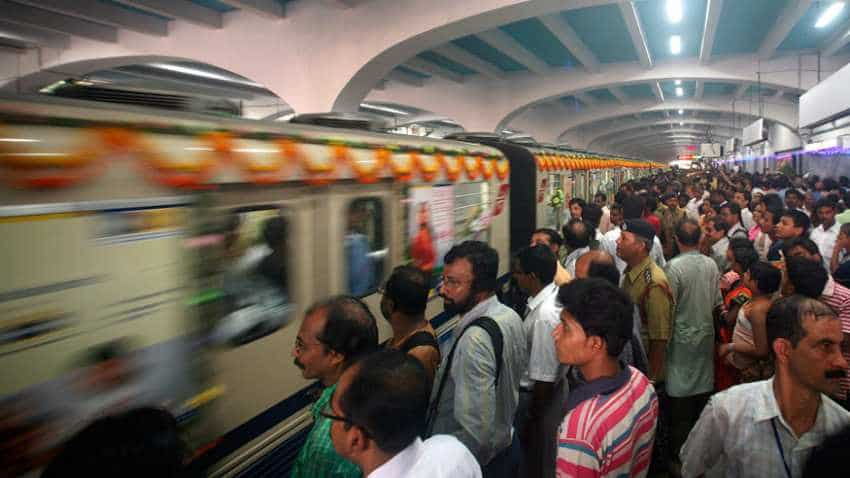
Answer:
xmin=617 ymin=219 xmax=675 ymax=473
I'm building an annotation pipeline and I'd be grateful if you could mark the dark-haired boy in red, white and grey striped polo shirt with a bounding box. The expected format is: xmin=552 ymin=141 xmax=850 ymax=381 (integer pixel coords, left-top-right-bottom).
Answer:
xmin=553 ymin=278 xmax=658 ymax=477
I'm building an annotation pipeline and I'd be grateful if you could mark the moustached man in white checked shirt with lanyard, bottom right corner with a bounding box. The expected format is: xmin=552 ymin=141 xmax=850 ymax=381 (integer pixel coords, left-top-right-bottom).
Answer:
xmin=681 ymin=295 xmax=850 ymax=478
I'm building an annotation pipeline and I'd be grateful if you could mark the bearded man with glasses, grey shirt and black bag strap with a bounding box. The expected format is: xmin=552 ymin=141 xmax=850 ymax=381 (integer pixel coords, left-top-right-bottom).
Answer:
xmin=428 ymin=241 xmax=528 ymax=477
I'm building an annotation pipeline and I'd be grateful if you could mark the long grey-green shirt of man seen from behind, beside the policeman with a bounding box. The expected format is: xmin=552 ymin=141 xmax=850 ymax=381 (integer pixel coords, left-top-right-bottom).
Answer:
xmin=664 ymin=251 xmax=723 ymax=397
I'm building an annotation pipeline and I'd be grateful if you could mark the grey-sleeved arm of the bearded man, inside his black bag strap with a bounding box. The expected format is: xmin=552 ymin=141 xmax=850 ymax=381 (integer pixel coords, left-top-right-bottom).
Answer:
xmin=451 ymin=327 xmax=496 ymax=464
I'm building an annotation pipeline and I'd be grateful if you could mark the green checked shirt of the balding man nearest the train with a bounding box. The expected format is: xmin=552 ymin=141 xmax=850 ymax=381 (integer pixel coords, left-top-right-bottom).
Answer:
xmin=290 ymin=384 xmax=362 ymax=478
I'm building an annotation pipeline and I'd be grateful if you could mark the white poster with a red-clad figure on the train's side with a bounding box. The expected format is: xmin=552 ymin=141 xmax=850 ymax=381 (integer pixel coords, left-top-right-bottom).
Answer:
xmin=407 ymin=185 xmax=455 ymax=274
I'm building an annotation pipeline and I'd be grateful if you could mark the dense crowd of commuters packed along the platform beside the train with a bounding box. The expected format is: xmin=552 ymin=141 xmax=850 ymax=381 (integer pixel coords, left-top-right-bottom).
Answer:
xmin=41 ymin=165 xmax=850 ymax=478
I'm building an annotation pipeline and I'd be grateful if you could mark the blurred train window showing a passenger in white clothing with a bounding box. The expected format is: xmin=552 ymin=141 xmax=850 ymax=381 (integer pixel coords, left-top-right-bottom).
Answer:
xmin=211 ymin=205 xmax=294 ymax=346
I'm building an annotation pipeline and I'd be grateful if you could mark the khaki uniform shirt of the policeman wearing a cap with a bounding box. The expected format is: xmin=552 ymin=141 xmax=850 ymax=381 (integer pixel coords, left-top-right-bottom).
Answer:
xmin=623 ymin=257 xmax=674 ymax=350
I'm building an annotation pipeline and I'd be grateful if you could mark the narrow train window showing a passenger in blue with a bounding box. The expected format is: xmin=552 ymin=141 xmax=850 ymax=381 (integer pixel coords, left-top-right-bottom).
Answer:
xmin=345 ymin=198 xmax=388 ymax=297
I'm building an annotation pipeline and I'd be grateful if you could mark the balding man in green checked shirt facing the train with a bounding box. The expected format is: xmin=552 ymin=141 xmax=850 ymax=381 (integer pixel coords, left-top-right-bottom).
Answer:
xmin=290 ymin=296 xmax=378 ymax=478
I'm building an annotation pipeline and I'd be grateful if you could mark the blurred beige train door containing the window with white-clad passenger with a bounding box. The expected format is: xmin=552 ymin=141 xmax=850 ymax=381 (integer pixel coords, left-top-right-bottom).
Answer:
xmin=197 ymin=185 xmax=322 ymax=455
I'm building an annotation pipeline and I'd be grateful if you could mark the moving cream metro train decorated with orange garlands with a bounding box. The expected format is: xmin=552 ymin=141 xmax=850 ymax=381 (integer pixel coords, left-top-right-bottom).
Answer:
xmin=0 ymin=97 xmax=659 ymax=476
